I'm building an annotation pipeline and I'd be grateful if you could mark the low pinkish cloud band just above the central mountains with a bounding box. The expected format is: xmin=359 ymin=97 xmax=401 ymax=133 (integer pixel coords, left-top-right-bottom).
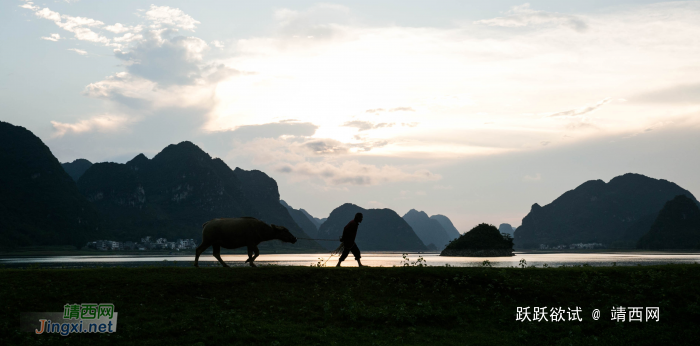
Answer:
xmin=276 ymin=160 xmax=442 ymax=186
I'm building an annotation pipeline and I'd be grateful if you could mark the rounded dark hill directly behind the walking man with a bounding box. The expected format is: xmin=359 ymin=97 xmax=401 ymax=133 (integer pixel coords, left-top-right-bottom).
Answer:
xmin=318 ymin=203 xmax=427 ymax=251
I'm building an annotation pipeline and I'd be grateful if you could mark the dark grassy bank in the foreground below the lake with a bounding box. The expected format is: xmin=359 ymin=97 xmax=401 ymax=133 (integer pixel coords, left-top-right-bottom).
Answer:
xmin=0 ymin=264 xmax=700 ymax=346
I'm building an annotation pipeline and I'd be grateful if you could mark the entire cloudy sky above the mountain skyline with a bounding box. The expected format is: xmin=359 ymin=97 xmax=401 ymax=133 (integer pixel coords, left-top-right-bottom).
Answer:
xmin=0 ymin=0 xmax=700 ymax=232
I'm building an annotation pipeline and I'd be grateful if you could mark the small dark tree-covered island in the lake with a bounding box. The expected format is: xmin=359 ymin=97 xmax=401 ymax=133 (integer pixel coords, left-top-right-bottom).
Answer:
xmin=440 ymin=223 xmax=515 ymax=257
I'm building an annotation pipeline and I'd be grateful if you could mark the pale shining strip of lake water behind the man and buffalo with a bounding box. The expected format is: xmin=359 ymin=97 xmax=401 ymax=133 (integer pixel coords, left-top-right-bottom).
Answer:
xmin=0 ymin=252 xmax=700 ymax=268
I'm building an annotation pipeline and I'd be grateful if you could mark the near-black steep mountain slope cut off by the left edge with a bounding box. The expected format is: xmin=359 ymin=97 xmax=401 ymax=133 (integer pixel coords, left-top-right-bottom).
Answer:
xmin=0 ymin=121 xmax=102 ymax=247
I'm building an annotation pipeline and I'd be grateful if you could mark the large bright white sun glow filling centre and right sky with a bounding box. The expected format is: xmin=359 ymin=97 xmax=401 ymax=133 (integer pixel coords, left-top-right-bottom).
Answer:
xmin=201 ymin=3 xmax=700 ymax=155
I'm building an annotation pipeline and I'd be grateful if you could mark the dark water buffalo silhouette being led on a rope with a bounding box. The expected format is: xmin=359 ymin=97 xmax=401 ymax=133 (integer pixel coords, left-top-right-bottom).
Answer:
xmin=194 ymin=217 xmax=297 ymax=267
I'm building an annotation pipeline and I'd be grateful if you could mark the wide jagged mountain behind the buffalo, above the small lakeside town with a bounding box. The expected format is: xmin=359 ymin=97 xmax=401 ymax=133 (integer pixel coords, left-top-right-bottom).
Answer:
xmin=78 ymin=141 xmax=322 ymax=250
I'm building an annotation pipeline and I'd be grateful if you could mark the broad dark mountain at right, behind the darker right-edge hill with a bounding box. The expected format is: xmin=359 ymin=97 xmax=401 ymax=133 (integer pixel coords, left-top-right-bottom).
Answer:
xmin=514 ymin=173 xmax=697 ymax=249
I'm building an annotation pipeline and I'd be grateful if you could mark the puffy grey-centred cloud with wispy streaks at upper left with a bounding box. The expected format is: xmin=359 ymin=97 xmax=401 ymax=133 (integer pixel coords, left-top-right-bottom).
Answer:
xmin=24 ymin=2 xmax=227 ymax=123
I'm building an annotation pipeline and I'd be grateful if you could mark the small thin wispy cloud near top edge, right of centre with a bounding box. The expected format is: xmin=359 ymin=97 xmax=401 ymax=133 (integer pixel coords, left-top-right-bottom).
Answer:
xmin=474 ymin=3 xmax=588 ymax=32
